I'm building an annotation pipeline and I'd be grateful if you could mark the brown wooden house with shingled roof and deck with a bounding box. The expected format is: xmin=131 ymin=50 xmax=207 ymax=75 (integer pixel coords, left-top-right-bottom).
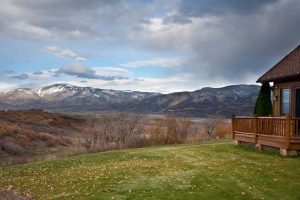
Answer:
xmin=232 ymin=45 xmax=300 ymax=155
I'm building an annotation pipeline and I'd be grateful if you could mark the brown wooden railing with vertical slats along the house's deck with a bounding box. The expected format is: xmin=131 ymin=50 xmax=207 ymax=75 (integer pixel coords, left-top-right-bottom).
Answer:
xmin=232 ymin=116 xmax=300 ymax=137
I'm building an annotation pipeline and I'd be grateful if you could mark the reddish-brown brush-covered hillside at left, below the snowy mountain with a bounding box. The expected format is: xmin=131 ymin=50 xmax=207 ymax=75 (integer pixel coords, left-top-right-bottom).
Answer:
xmin=0 ymin=110 xmax=85 ymax=166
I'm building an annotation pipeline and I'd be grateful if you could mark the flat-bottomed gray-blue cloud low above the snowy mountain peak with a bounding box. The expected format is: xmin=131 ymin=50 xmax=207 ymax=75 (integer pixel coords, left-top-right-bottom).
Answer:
xmin=57 ymin=63 xmax=128 ymax=81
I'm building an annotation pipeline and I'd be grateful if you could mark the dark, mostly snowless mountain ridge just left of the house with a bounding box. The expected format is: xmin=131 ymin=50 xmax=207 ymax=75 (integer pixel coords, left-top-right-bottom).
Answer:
xmin=126 ymin=85 xmax=259 ymax=117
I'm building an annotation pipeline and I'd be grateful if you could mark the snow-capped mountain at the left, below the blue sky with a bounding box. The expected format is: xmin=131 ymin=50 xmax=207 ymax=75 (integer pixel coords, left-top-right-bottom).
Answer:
xmin=0 ymin=84 xmax=158 ymax=110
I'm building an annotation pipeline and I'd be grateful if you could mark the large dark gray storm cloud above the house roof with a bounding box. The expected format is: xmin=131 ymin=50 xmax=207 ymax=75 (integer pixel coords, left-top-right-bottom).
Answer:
xmin=183 ymin=0 xmax=300 ymax=82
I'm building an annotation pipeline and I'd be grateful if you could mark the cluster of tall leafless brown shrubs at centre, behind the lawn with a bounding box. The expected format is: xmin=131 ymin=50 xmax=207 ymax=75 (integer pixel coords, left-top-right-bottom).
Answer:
xmin=82 ymin=112 xmax=192 ymax=151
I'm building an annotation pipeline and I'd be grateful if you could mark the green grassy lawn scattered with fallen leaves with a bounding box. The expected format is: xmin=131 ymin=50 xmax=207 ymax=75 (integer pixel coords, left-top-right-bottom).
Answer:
xmin=0 ymin=142 xmax=300 ymax=200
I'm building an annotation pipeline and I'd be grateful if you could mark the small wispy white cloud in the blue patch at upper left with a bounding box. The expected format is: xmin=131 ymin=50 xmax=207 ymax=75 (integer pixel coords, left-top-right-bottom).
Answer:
xmin=45 ymin=46 xmax=86 ymax=61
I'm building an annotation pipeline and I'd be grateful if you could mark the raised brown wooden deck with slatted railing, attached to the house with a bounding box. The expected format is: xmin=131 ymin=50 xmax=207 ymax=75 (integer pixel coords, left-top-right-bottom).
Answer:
xmin=232 ymin=116 xmax=300 ymax=155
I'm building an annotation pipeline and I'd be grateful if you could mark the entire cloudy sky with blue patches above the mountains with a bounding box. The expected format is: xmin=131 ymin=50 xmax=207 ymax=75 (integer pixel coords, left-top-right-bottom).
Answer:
xmin=0 ymin=0 xmax=300 ymax=93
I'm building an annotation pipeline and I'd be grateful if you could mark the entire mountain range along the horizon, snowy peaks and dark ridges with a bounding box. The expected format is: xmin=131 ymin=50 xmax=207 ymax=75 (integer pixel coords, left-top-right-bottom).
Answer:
xmin=0 ymin=84 xmax=260 ymax=117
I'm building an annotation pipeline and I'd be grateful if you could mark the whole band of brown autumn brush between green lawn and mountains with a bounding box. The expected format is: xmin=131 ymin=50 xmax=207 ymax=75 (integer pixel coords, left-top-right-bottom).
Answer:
xmin=0 ymin=110 xmax=231 ymax=165
